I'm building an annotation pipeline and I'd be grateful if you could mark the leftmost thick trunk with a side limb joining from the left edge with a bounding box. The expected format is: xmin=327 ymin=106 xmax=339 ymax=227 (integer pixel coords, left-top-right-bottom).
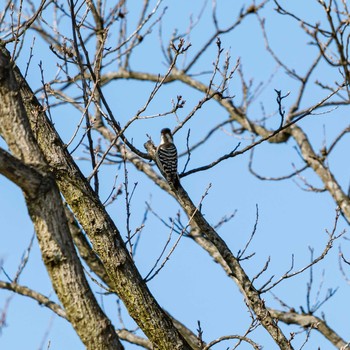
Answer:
xmin=0 ymin=47 xmax=124 ymax=350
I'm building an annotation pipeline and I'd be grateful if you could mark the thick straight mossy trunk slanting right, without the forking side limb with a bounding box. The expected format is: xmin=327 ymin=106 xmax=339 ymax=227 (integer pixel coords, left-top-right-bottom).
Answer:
xmin=2 ymin=48 xmax=192 ymax=350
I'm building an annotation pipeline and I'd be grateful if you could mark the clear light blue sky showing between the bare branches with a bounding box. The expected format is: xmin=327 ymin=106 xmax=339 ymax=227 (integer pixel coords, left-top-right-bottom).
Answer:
xmin=0 ymin=0 xmax=350 ymax=350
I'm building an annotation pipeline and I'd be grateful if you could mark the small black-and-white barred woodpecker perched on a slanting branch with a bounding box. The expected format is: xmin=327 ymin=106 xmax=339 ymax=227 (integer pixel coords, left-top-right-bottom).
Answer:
xmin=155 ymin=128 xmax=180 ymax=189
